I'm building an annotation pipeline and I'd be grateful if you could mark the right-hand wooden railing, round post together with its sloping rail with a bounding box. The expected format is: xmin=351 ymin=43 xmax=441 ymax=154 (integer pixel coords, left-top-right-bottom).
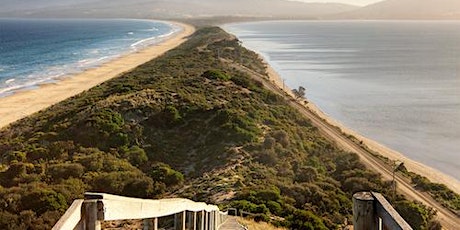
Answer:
xmin=353 ymin=192 xmax=412 ymax=230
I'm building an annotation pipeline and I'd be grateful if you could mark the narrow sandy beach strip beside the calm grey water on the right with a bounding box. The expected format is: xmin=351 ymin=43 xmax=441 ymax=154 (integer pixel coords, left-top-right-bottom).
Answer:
xmin=259 ymin=54 xmax=460 ymax=194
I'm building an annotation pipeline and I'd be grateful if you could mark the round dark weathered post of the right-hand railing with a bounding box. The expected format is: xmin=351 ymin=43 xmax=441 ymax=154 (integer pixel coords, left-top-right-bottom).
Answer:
xmin=353 ymin=192 xmax=378 ymax=230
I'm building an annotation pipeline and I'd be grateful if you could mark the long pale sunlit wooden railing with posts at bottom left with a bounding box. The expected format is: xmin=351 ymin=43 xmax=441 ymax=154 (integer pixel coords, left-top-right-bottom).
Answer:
xmin=53 ymin=193 xmax=227 ymax=230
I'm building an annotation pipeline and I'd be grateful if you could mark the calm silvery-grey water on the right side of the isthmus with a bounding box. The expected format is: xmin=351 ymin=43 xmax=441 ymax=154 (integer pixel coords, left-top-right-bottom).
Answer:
xmin=223 ymin=21 xmax=460 ymax=180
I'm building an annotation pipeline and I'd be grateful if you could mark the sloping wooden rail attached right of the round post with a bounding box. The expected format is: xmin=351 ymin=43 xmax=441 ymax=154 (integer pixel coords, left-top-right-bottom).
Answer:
xmin=372 ymin=192 xmax=412 ymax=230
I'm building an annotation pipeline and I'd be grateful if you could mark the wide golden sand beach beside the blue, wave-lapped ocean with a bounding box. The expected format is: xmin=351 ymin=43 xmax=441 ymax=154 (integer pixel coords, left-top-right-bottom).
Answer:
xmin=0 ymin=22 xmax=195 ymax=129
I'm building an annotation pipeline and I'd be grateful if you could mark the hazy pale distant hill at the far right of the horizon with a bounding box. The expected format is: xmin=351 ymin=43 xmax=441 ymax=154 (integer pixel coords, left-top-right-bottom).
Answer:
xmin=332 ymin=0 xmax=460 ymax=20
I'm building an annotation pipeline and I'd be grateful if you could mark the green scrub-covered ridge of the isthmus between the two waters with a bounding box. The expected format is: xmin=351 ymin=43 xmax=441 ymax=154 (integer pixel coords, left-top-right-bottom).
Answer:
xmin=0 ymin=28 xmax=440 ymax=229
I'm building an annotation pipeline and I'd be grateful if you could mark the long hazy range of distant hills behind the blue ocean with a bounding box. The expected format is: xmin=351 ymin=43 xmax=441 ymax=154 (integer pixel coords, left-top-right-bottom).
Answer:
xmin=0 ymin=0 xmax=356 ymax=18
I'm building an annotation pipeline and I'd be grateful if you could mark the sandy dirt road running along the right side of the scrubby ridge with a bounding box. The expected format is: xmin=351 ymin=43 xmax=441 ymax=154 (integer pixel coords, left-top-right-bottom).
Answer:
xmin=227 ymin=61 xmax=460 ymax=230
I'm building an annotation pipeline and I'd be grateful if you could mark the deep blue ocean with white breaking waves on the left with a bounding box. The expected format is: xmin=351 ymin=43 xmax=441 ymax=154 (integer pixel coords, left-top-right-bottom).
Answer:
xmin=0 ymin=19 xmax=179 ymax=97
